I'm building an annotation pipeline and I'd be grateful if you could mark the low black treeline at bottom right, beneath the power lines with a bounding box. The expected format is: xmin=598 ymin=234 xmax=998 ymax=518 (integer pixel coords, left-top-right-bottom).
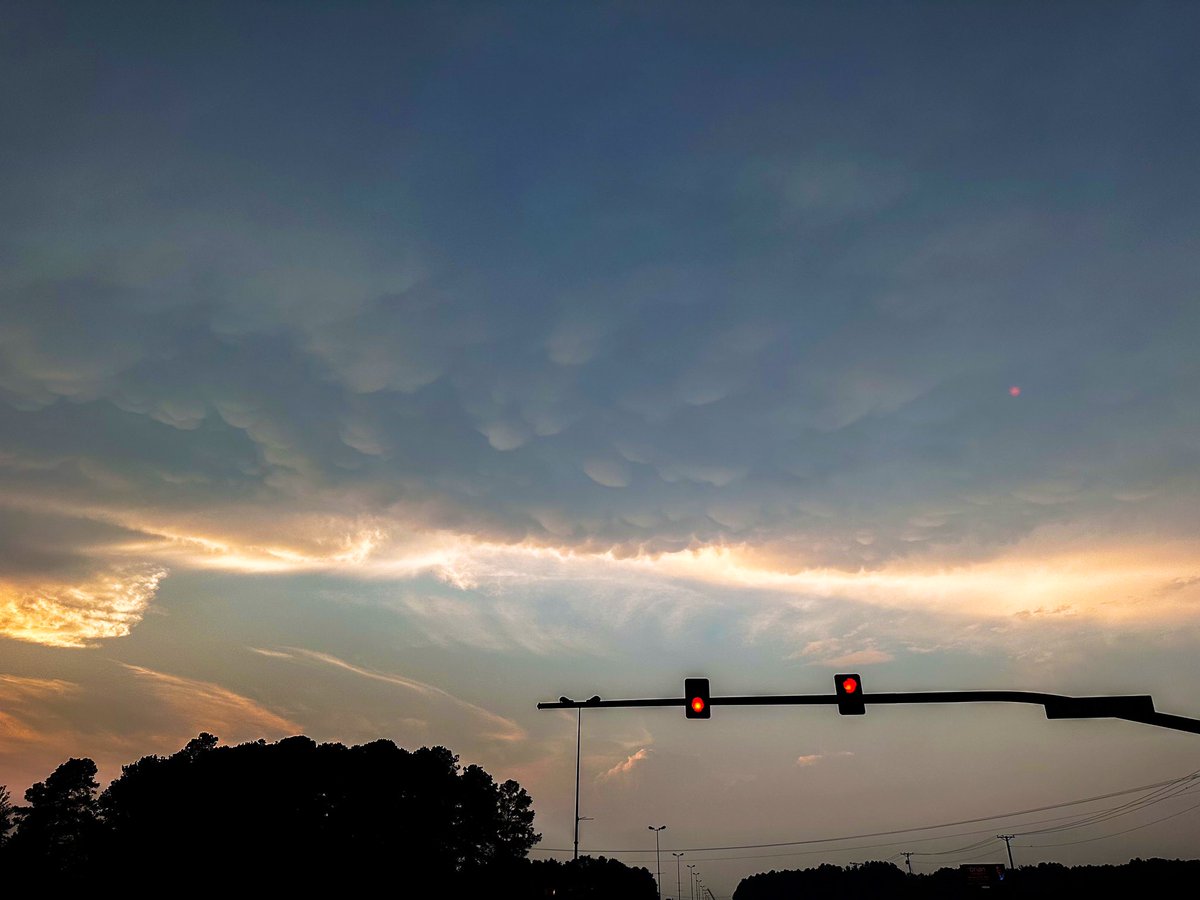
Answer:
xmin=733 ymin=859 xmax=1200 ymax=900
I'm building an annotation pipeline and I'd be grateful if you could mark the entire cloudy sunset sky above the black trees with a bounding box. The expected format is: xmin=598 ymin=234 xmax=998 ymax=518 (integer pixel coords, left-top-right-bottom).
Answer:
xmin=0 ymin=0 xmax=1200 ymax=898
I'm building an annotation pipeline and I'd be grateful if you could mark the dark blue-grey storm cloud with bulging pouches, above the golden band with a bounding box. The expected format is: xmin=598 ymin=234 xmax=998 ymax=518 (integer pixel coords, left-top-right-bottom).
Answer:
xmin=0 ymin=1 xmax=1200 ymax=578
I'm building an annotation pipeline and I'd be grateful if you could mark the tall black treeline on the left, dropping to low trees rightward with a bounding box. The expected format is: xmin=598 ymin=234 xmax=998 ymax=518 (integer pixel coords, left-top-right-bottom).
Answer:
xmin=0 ymin=733 xmax=654 ymax=900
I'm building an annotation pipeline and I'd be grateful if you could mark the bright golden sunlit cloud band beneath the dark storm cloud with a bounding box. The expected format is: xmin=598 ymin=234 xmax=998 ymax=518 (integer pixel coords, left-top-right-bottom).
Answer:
xmin=0 ymin=501 xmax=1200 ymax=648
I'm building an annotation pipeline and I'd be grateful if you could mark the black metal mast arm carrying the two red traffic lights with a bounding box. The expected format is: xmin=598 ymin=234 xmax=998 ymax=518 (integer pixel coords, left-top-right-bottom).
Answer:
xmin=538 ymin=691 xmax=1200 ymax=734
